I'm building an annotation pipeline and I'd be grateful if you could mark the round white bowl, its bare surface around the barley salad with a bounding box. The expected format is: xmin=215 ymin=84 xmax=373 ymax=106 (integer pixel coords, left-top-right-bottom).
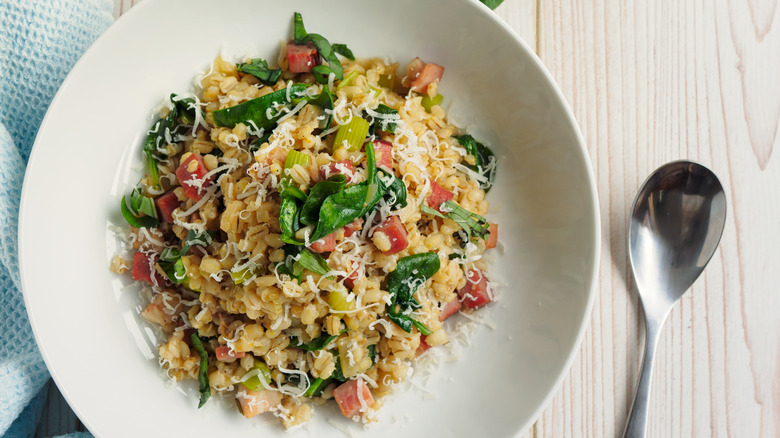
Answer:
xmin=19 ymin=0 xmax=599 ymax=437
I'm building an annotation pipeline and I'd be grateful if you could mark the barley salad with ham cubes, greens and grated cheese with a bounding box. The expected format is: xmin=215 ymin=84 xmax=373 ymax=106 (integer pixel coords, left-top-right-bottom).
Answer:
xmin=111 ymin=13 xmax=498 ymax=429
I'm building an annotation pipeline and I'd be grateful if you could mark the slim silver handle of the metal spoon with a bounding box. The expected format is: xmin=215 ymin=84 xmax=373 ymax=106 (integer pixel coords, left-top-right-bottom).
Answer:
xmin=623 ymin=312 xmax=666 ymax=438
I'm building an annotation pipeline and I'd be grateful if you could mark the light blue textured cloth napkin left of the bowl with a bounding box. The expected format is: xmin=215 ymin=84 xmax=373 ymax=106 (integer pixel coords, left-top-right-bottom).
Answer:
xmin=0 ymin=0 xmax=114 ymax=437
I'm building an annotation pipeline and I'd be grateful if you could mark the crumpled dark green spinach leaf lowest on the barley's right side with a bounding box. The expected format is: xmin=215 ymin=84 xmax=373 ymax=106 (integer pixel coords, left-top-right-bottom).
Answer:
xmin=387 ymin=252 xmax=441 ymax=336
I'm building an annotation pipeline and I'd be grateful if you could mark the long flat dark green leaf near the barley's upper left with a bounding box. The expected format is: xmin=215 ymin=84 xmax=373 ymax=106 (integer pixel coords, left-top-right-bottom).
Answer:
xmin=212 ymin=84 xmax=309 ymax=130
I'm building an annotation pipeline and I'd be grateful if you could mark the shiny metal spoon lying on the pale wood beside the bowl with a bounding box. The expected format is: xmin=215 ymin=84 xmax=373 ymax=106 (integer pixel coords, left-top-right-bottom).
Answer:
xmin=623 ymin=161 xmax=726 ymax=438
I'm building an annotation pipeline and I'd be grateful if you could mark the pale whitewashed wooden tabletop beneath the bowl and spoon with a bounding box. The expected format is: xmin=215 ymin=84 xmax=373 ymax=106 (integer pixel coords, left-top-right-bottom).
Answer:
xmin=39 ymin=0 xmax=780 ymax=438
